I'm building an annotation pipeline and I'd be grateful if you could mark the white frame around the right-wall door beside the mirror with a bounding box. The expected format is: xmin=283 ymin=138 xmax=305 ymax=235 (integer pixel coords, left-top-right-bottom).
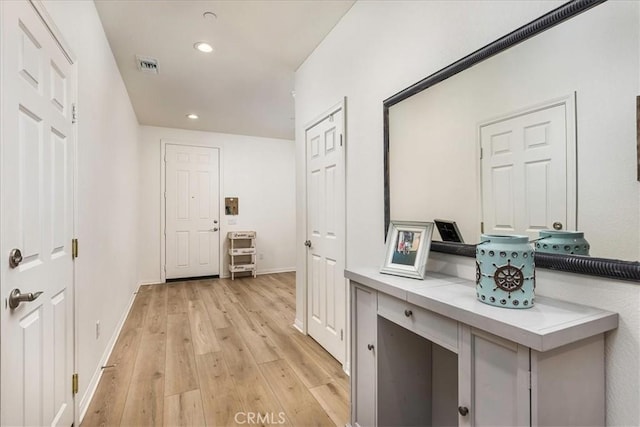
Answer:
xmin=302 ymin=96 xmax=351 ymax=373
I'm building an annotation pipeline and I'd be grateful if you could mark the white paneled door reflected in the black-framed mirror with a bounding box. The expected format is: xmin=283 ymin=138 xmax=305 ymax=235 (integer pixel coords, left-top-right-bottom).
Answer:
xmin=479 ymin=98 xmax=576 ymax=242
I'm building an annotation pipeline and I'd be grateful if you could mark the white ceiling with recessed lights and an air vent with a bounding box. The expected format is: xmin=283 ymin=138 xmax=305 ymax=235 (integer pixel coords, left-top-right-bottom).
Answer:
xmin=95 ymin=0 xmax=355 ymax=139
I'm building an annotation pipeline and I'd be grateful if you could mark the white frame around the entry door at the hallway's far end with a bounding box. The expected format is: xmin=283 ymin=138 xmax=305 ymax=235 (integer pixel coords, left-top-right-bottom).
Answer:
xmin=159 ymin=138 xmax=226 ymax=283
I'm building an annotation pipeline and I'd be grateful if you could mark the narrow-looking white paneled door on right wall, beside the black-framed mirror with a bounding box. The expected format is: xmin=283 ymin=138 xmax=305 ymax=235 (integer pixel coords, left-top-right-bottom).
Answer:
xmin=306 ymin=107 xmax=346 ymax=363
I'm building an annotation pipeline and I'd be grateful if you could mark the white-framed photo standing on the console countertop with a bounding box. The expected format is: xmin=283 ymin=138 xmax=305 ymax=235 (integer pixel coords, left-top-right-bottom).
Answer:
xmin=380 ymin=220 xmax=434 ymax=280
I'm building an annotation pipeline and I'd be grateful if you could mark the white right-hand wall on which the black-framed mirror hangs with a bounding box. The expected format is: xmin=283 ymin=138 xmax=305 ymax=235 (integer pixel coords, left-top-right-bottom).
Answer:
xmin=296 ymin=0 xmax=640 ymax=425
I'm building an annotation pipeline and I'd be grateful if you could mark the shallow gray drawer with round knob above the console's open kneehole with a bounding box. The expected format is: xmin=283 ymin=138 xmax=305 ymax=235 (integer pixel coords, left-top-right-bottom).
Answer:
xmin=378 ymin=293 xmax=458 ymax=353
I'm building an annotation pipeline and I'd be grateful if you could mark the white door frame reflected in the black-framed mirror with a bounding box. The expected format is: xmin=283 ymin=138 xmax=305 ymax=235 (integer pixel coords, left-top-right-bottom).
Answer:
xmin=475 ymin=92 xmax=578 ymax=234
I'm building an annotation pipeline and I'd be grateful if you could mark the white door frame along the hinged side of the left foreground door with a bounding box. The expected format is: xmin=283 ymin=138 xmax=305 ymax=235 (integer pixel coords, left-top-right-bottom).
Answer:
xmin=0 ymin=0 xmax=80 ymax=425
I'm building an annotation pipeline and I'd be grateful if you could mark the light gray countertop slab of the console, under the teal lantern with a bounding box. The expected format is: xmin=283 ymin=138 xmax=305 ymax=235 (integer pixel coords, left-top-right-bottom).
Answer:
xmin=345 ymin=268 xmax=618 ymax=351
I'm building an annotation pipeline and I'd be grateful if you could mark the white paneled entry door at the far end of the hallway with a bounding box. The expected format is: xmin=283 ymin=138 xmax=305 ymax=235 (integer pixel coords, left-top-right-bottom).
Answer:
xmin=165 ymin=144 xmax=220 ymax=279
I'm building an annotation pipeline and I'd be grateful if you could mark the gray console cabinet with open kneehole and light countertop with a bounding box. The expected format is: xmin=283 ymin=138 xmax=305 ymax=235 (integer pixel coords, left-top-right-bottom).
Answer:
xmin=345 ymin=270 xmax=618 ymax=427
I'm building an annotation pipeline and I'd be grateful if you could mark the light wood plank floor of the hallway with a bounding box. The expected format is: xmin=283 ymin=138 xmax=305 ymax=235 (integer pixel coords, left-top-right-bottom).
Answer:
xmin=82 ymin=273 xmax=349 ymax=427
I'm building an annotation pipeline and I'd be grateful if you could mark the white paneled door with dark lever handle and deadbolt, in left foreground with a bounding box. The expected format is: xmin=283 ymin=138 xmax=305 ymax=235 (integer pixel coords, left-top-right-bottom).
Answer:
xmin=0 ymin=1 xmax=76 ymax=426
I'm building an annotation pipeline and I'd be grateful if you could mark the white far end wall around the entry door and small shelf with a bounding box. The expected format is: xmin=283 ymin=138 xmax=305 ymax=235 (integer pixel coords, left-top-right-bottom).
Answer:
xmin=138 ymin=126 xmax=295 ymax=283
